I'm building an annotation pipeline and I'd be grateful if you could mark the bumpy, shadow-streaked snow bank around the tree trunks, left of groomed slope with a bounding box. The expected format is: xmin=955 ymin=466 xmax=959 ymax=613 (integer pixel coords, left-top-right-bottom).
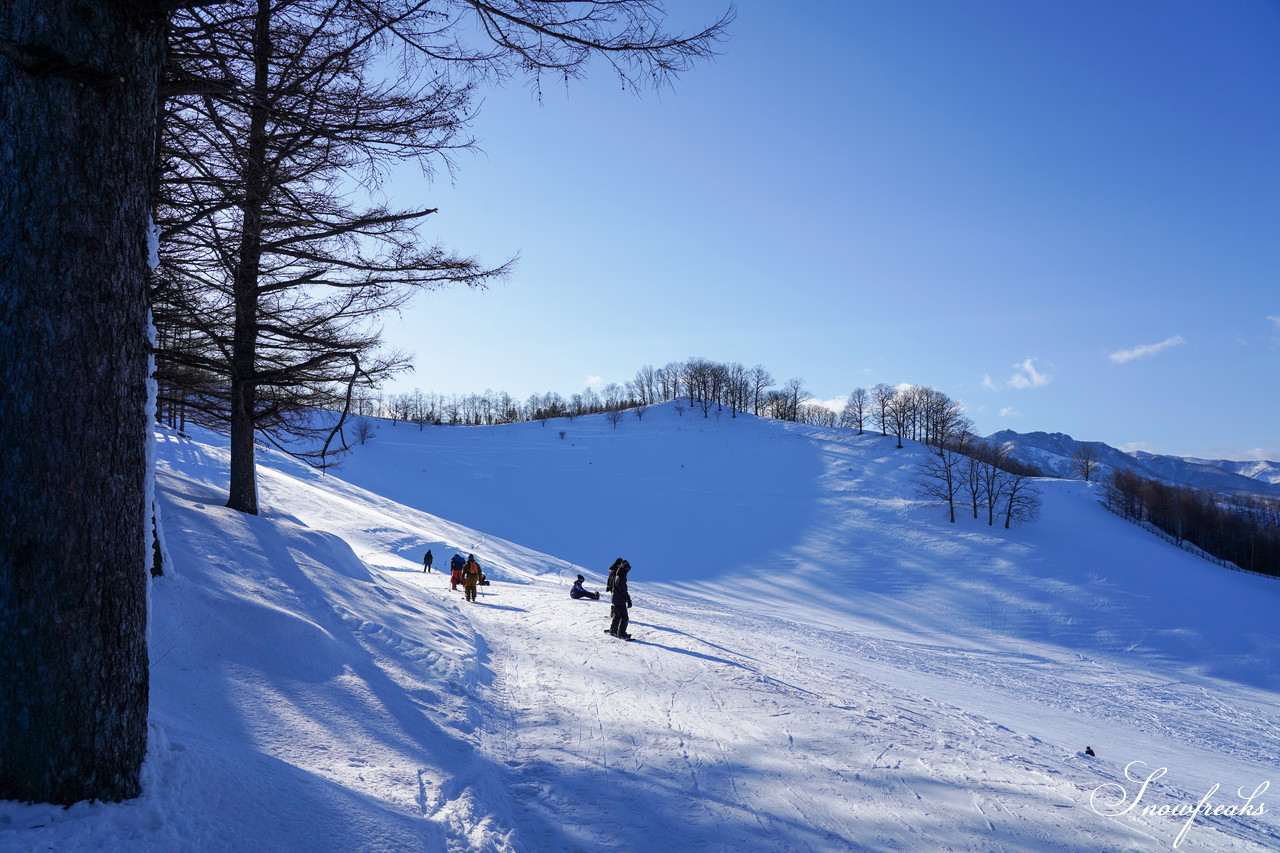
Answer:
xmin=0 ymin=434 xmax=506 ymax=853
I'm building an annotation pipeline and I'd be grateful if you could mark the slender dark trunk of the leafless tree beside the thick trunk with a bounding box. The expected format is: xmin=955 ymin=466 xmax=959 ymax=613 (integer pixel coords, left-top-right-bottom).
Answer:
xmin=227 ymin=0 xmax=271 ymax=515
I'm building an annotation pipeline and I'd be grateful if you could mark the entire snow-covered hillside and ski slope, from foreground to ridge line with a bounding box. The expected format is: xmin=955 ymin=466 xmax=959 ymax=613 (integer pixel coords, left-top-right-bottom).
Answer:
xmin=0 ymin=406 xmax=1280 ymax=853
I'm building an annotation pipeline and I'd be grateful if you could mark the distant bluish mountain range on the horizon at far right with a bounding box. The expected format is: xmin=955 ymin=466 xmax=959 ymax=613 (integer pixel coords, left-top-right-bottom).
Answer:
xmin=986 ymin=429 xmax=1280 ymax=497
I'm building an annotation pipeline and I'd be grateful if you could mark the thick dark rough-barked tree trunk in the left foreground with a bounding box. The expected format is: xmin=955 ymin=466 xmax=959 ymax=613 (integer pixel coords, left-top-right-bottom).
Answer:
xmin=0 ymin=0 xmax=164 ymax=803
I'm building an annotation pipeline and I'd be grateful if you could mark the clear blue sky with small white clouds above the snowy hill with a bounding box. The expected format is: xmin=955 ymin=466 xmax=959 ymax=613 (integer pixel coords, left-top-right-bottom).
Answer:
xmin=385 ymin=0 xmax=1280 ymax=460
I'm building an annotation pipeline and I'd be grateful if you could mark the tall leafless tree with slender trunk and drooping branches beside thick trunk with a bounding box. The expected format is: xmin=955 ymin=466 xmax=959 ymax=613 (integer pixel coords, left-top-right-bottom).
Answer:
xmin=154 ymin=0 xmax=504 ymax=512
